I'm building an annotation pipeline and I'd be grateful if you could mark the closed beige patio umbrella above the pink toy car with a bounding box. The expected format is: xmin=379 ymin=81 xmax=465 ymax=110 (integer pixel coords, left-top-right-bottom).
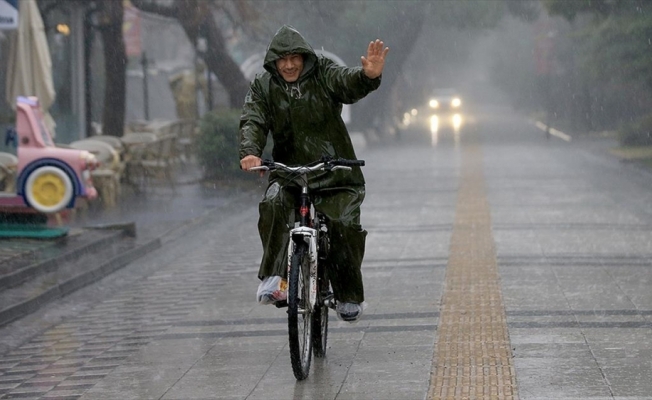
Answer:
xmin=6 ymin=0 xmax=55 ymax=136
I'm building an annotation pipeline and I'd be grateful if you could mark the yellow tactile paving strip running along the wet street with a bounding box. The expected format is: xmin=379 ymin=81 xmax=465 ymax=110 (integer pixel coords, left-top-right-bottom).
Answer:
xmin=428 ymin=142 xmax=518 ymax=399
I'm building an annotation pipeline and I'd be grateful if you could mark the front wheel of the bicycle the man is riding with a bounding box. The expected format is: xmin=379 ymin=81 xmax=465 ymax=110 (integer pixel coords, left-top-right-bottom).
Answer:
xmin=288 ymin=242 xmax=313 ymax=380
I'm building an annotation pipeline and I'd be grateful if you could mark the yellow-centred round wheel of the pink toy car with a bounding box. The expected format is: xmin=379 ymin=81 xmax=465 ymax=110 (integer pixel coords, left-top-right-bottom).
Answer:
xmin=24 ymin=166 xmax=73 ymax=213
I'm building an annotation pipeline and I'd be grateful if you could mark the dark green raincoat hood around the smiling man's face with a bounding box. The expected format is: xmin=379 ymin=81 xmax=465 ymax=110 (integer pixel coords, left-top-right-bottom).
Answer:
xmin=263 ymin=25 xmax=317 ymax=79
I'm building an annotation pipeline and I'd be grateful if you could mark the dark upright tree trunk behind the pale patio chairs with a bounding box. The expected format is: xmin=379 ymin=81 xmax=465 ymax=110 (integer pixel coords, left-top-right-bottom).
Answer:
xmin=100 ymin=1 xmax=127 ymax=136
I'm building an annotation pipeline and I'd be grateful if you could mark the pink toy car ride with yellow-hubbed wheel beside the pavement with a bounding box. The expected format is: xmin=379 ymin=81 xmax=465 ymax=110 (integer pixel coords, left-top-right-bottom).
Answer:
xmin=0 ymin=97 xmax=98 ymax=214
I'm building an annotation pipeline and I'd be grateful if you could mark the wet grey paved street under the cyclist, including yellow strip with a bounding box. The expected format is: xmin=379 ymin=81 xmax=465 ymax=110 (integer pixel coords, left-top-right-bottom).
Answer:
xmin=0 ymin=110 xmax=652 ymax=400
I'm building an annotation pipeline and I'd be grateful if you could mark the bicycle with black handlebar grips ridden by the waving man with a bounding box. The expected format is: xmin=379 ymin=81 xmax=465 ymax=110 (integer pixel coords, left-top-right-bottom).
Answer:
xmin=251 ymin=157 xmax=365 ymax=380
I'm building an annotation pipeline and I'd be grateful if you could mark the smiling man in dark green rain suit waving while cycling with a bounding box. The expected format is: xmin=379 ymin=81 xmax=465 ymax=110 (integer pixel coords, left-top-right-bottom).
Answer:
xmin=240 ymin=25 xmax=389 ymax=322
